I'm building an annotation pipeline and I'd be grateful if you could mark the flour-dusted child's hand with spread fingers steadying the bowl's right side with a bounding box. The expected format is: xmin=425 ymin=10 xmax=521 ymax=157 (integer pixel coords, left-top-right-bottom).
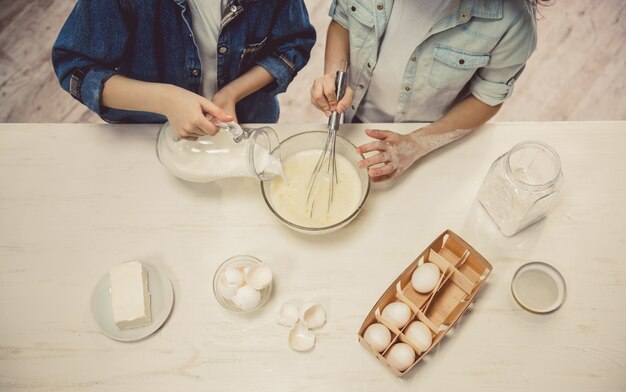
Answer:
xmin=356 ymin=129 xmax=429 ymax=182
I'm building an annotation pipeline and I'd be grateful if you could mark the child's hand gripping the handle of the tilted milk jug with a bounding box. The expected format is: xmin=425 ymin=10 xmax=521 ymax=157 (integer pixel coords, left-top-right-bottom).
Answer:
xmin=162 ymin=86 xmax=234 ymax=139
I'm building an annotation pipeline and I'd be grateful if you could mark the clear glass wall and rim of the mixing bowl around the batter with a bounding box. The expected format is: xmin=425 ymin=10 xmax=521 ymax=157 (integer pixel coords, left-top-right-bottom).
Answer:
xmin=261 ymin=131 xmax=370 ymax=234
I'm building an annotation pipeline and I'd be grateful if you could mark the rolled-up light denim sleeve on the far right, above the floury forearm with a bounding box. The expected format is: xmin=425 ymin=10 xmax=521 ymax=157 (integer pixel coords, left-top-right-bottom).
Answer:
xmin=470 ymin=3 xmax=537 ymax=106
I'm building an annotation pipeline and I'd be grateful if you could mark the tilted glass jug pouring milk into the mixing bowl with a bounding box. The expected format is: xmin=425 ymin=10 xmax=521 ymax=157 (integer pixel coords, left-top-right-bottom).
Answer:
xmin=157 ymin=122 xmax=282 ymax=182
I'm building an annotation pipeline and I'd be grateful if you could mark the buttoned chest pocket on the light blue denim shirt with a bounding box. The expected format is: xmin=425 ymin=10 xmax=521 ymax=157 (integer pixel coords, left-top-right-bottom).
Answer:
xmin=430 ymin=45 xmax=489 ymax=89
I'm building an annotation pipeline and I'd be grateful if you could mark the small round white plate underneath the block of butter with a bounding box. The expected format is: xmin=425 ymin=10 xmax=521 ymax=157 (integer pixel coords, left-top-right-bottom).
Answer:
xmin=91 ymin=262 xmax=174 ymax=342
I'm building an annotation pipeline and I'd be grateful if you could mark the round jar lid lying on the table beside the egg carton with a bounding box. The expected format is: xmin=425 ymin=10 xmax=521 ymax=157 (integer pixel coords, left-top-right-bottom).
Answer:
xmin=511 ymin=261 xmax=565 ymax=313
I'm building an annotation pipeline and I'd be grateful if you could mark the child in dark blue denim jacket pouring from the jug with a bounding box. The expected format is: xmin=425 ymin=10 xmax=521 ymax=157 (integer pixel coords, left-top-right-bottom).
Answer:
xmin=52 ymin=0 xmax=315 ymax=138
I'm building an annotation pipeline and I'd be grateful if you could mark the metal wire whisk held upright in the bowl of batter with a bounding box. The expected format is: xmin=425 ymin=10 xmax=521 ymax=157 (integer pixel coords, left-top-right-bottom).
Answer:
xmin=306 ymin=60 xmax=348 ymax=216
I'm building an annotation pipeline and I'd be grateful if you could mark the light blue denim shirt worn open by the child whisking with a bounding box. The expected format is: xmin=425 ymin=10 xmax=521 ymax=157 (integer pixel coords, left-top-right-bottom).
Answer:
xmin=329 ymin=0 xmax=537 ymax=122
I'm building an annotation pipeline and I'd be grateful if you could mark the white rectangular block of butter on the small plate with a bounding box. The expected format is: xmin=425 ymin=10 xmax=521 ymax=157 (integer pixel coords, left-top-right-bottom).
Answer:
xmin=109 ymin=261 xmax=152 ymax=329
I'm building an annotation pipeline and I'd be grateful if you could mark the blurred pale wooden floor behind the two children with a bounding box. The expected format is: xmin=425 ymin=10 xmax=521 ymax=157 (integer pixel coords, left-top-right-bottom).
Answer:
xmin=0 ymin=0 xmax=626 ymax=123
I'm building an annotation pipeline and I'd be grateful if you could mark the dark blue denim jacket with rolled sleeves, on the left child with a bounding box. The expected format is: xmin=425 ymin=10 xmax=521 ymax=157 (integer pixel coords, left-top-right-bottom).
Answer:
xmin=52 ymin=0 xmax=315 ymax=123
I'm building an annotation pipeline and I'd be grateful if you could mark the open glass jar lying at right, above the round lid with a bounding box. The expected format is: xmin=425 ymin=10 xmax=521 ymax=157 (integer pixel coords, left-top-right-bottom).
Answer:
xmin=478 ymin=141 xmax=563 ymax=236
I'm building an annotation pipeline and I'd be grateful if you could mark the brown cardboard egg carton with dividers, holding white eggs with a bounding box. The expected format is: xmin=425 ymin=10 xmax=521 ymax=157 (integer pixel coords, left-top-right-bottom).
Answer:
xmin=359 ymin=230 xmax=493 ymax=377
